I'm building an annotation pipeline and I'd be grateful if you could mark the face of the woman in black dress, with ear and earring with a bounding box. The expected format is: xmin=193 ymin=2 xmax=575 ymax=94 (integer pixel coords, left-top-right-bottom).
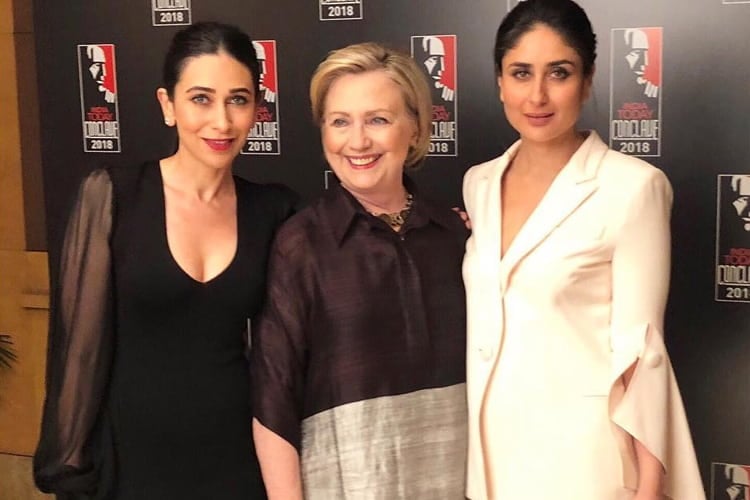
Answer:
xmin=157 ymin=52 xmax=255 ymax=168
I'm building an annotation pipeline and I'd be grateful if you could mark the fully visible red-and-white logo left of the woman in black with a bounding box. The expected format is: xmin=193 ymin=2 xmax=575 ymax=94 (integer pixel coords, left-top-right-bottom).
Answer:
xmin=78 ymin=44 xmax=120 ymax=153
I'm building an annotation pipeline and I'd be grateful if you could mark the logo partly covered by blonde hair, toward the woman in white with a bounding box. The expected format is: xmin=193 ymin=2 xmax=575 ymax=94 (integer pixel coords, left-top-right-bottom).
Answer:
xmin=411 ymin=35 xmax=458 ymax=156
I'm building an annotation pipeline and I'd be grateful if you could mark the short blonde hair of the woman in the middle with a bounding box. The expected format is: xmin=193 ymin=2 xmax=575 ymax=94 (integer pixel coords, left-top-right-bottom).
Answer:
xmin=310 ymin=42 xmax=432 ymax=168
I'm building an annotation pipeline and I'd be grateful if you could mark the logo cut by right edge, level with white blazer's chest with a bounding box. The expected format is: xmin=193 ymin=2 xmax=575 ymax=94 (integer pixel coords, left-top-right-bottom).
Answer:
xmin=715 ymin=174 xmax=750 ymax=302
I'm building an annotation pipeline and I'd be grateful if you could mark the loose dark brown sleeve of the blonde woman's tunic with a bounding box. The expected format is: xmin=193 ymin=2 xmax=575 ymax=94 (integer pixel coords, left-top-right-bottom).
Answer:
xmin=251 ymin=227 xmax=311 ymax=451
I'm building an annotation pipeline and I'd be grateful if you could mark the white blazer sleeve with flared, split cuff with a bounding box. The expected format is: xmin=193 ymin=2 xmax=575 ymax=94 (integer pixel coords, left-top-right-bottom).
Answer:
xmin=610 ymin=169 xmax=705 ymax=500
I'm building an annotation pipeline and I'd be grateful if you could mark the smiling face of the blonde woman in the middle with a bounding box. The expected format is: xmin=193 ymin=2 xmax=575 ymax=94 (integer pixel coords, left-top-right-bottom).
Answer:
xmin=321 ymin=70 xmax=417 ymax=201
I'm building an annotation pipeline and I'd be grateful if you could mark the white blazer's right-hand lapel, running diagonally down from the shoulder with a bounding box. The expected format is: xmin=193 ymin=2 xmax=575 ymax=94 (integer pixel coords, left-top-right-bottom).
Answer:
xmin=495 ymin=131 xmax=608 ymax=290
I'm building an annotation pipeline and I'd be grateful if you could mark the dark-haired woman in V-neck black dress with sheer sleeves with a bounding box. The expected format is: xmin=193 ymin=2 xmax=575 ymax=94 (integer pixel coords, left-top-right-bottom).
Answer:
xmin=34 ymin=23 xmax=294 ymax=500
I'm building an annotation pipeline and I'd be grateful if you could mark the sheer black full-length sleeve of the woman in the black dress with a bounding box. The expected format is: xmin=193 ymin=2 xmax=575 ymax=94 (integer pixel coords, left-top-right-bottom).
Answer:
xmin=34 ymin=170 xmax=113 ymax=498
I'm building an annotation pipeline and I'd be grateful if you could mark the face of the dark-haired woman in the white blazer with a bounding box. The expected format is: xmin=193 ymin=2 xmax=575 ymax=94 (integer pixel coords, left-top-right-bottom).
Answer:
xmin=497 ymin=24 xmax=592 ymax=147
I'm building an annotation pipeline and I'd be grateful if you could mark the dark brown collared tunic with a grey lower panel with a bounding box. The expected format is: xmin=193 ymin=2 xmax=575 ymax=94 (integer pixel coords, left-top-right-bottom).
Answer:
xmin=252 ymin=179 xmax=467 ymax=500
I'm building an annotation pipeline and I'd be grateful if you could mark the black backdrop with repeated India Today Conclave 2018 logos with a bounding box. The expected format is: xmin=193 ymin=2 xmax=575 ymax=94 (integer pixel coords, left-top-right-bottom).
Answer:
xmin=34 ymin=0 xmax=750 ymax=500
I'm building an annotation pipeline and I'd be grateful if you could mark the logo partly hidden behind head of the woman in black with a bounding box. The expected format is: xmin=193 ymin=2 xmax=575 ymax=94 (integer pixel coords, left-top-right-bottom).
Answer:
xmin=242 ymin=40 xmax=281 ymax=155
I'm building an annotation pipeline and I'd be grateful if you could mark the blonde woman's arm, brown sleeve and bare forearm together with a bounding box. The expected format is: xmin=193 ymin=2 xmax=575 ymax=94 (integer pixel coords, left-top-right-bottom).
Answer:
xmin=251 ymin=223 xmax=314 ymax=500
